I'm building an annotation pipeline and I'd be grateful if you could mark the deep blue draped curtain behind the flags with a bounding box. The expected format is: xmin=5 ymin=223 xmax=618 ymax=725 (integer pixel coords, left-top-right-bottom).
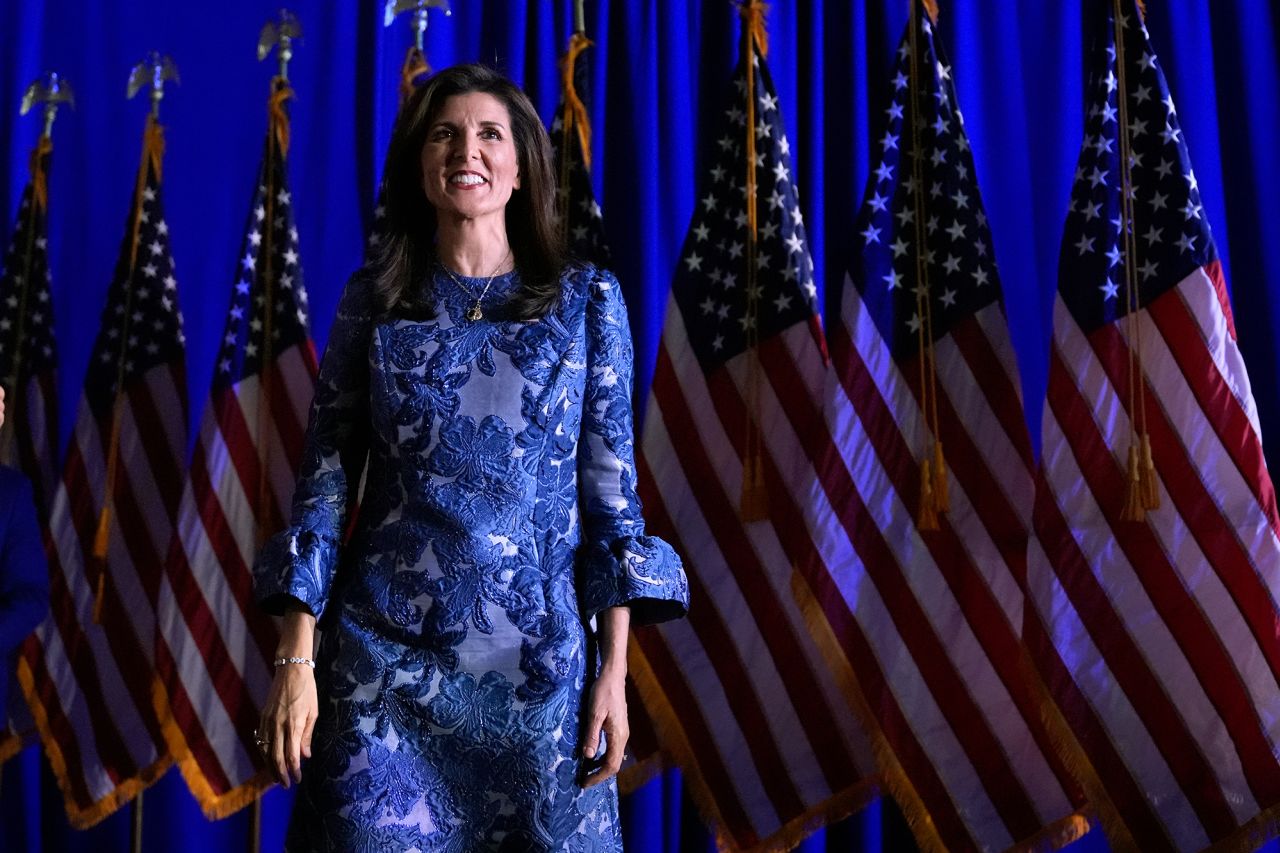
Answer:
xmin=0 ymin=0 xmax=1280 ymax=853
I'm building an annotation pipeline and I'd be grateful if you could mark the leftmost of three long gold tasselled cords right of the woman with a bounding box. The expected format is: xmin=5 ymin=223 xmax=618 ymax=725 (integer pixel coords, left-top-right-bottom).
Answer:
xmin=739 ymin=0 xmax=769 ymax=521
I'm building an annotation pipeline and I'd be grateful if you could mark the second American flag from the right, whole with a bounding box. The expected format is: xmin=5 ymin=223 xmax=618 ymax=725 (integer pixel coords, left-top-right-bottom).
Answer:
xmin=810 ymin=5 xmax=1088 ymax=850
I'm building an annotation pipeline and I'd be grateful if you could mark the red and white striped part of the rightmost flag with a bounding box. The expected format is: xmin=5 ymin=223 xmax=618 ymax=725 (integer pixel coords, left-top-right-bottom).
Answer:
xmin=1027 ymin=261 xmax=1280 ymax=850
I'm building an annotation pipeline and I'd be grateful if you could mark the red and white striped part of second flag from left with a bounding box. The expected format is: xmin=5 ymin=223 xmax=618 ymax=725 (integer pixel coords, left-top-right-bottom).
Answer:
xmin=19 ymin=361 xmax=187 ymax=827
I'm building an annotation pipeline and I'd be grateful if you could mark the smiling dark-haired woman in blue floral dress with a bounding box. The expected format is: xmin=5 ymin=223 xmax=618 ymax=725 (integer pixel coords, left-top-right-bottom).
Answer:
xmin=256 ymin=65 xmax=689 ymax=852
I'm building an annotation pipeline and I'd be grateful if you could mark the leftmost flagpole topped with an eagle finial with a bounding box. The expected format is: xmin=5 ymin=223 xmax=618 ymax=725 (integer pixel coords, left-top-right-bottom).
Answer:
xmin=0 ymin=72 xmax=76 ymax=467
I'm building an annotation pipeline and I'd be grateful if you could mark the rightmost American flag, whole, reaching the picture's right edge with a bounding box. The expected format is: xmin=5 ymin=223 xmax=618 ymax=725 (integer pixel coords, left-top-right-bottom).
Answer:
xmin=1027 ymin=0 xmax=1280 ymax=850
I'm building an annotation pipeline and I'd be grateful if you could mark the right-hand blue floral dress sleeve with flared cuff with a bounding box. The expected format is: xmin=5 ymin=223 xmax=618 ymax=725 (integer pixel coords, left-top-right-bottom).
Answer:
xmin=577 ymin=272 xmax=689 ymax=625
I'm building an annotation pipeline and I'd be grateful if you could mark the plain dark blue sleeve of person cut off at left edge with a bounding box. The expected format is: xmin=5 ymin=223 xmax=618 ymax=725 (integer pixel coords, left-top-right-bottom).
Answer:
xmin=0 ymin=466 xmax=49 ymax=660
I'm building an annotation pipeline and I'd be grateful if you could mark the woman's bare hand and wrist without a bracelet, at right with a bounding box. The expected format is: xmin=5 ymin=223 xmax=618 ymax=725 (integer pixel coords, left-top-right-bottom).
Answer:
xmin=582 ymin=607 xmax=631 ymax=788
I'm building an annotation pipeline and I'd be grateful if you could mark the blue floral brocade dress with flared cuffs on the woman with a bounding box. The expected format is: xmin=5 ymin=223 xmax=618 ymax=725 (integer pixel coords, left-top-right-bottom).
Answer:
xmin=256 ymin=266 xmax=689 ymax=853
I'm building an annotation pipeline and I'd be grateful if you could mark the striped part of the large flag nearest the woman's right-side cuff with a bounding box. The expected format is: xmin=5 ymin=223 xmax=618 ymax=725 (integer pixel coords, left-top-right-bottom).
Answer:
xmin=637 ymin=298 xmax=873 ymax=849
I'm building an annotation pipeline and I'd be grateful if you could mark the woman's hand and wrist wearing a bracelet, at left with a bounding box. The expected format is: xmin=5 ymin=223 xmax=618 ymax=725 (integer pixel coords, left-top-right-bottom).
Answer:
xmin=257 ymin=610 xmax=320 ymax=788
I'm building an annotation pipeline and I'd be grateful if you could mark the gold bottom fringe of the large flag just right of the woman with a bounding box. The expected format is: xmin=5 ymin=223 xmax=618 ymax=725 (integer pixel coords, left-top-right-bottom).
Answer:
xmin=627 ymin=643 xmax=879 ymax=853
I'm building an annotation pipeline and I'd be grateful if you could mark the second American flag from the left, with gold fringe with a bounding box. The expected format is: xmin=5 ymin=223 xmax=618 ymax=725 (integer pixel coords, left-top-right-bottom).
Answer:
xmin=19 ymin=118 xmax=187 ymax=827
